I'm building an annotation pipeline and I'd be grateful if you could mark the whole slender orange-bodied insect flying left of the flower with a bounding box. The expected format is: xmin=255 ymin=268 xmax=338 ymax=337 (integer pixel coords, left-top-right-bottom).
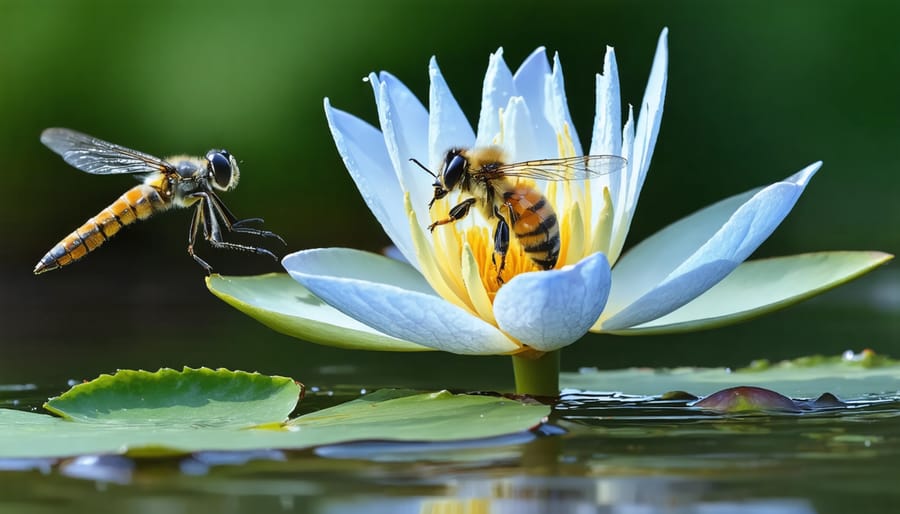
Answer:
xmin=34 ymin=128 xmax=284 ymax=274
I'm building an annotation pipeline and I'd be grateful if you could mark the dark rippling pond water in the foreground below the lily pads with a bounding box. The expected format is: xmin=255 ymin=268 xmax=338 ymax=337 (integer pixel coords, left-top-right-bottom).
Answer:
xmin=0 ymin=391 xmax=900 ymax=513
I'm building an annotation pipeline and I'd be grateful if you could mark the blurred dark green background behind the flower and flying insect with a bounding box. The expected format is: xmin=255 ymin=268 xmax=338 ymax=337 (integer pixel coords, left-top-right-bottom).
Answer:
xmin=0 ymin=0 xmax=900 ymax=388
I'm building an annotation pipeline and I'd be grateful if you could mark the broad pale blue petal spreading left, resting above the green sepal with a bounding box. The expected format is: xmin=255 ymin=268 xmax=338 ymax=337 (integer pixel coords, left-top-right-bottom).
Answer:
xmin=282 ymin=248 xmax=519 ymax=355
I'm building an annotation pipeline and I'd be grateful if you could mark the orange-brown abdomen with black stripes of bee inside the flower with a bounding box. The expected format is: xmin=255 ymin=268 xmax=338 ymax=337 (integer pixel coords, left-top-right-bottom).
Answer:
xmin=503 ymin=186 xmax=560 ymax=269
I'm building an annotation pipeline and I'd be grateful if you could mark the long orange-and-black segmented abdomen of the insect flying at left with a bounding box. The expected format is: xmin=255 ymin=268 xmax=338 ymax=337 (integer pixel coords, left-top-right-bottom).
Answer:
xmin=34 ymin=184 xmax=168 ymax=274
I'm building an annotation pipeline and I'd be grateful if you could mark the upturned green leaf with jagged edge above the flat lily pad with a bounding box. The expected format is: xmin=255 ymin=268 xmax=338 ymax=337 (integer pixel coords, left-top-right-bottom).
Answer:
xmin=44 ymin=367 xmax=302 ymax=427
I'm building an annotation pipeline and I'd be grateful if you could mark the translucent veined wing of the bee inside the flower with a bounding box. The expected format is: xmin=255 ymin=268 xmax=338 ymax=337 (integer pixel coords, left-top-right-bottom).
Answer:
xmin=493 ymin=155 xmax=628 ymax=180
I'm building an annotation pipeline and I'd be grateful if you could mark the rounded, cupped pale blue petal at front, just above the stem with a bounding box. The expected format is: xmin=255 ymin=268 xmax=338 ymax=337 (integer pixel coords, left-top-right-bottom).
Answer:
xmin=494 ymin=253 xmax=610 ymax=351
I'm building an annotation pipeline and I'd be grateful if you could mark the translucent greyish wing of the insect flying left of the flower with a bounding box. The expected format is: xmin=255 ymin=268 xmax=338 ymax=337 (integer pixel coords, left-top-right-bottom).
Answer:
xmin=41 ymin=128 xmax=174 ymax=175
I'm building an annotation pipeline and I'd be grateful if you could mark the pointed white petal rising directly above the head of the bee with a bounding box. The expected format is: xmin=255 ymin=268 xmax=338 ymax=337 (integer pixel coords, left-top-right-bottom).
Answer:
xmin=425 ymin=57 xmax=475 ymax=166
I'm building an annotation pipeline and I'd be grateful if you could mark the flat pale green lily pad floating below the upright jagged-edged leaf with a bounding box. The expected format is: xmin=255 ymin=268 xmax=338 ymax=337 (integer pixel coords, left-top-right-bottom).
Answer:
xmin=0 ymin=391 xmax=550 ymax=458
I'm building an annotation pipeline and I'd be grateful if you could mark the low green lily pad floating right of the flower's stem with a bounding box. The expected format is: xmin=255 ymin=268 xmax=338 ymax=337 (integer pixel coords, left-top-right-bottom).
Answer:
xmin=560 ymin=352 xmax=900 ymax=400
